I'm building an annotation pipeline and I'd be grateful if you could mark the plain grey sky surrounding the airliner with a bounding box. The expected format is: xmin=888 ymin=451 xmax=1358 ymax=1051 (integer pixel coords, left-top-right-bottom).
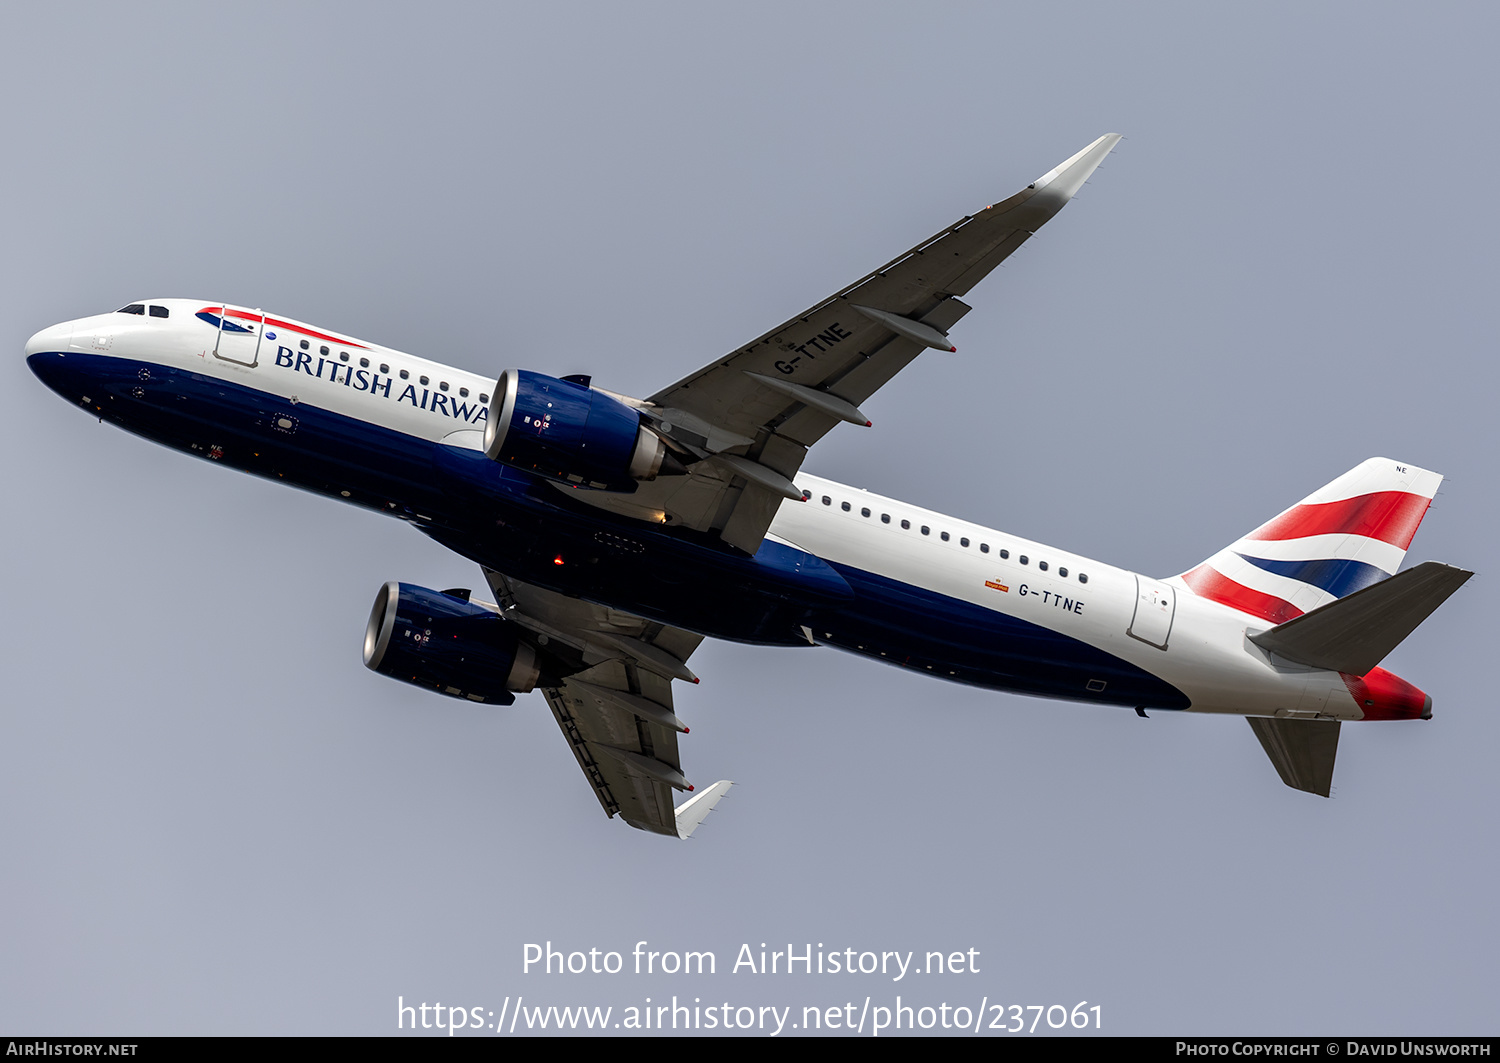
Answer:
xmin=0 ymin=3 xmax=1500 ymax=1035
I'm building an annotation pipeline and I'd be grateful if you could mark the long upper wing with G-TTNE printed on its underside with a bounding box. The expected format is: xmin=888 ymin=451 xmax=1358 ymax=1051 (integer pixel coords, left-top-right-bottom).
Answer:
xmin=575 ymin=133 xmax=1121 ymax=553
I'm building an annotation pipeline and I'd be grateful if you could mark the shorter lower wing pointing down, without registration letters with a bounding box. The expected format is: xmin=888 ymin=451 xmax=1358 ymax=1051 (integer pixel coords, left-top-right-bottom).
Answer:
xmin=485 ymin=568 xmax=729 ymax=838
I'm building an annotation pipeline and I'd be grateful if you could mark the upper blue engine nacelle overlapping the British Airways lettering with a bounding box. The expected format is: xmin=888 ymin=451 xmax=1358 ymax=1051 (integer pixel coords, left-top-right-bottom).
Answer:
xmin=485 ymin=369 xmax=668 ymax=492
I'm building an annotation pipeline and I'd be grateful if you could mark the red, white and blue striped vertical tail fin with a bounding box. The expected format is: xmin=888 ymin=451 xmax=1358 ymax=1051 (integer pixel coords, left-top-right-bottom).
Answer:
xmin=1179 ymin=457 xmax=1443 ymax=624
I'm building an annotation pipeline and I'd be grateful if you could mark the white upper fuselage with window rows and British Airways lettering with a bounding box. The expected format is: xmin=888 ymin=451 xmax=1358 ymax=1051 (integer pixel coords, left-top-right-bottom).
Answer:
xmin=27 ymin=300 xmax=1362 ymax=720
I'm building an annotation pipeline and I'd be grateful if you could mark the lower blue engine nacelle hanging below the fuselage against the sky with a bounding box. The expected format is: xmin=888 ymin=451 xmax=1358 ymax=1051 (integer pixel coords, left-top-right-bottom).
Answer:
xmin=365 ymin=582 xmax=539 ymax=705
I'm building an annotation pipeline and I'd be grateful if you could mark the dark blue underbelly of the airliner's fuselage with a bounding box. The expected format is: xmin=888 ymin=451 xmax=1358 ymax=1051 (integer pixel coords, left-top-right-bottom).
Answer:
xmin=29 ymin=352 xmax=1188 ymax=709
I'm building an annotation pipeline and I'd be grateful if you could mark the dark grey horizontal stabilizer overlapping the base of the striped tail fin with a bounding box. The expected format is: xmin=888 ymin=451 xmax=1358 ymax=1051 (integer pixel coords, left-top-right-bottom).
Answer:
xmin=1250 ymin=561 xmax=1473 ymax=674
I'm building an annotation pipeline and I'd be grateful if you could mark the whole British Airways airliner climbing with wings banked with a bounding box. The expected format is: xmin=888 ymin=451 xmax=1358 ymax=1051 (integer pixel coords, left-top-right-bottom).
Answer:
xmin=26 ymin=133 xmax=1472 ymax=838
